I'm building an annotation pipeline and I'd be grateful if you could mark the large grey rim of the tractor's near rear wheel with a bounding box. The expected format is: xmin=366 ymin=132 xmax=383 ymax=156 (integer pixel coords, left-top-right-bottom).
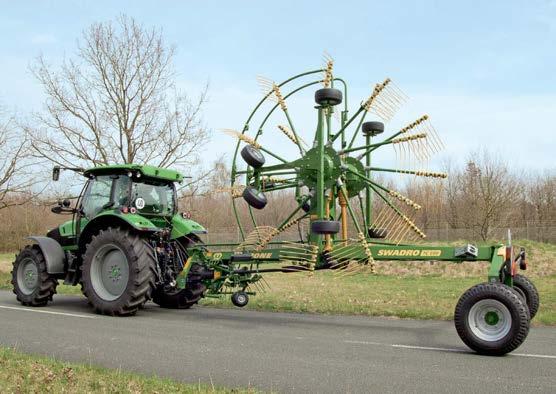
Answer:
xmin=91 ymin=244 xmax=129 ymax=301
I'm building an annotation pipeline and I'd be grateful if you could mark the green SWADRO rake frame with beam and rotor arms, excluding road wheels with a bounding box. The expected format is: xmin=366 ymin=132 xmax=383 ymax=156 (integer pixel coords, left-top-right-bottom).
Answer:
xmin=182 ymin=61 xmax=524 ymax=296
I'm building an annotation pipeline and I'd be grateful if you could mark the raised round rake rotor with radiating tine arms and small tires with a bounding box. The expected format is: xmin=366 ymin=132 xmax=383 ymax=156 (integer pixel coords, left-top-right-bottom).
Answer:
xmin=225 ymin=53 xmax=446 ymax=275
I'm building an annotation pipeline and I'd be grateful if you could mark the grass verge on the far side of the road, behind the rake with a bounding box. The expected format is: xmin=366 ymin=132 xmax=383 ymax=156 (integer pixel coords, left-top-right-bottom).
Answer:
xmin=0 ymin=241 xmax=556 ymax=325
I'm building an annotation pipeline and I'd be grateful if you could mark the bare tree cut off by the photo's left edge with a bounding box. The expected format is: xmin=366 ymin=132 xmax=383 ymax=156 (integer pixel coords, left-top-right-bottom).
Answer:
xmin=0 ymin=104 xmax=32 ymax=209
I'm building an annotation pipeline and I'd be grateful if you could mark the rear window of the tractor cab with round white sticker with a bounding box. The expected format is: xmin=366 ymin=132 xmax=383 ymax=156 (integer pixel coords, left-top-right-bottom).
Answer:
xmin=131 ymin=180 xmax=175 ymax=215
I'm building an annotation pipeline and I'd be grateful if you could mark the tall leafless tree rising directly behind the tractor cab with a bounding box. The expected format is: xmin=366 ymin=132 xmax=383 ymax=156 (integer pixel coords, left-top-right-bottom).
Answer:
xmin=27 ymin=16 xmax=208 ymax=172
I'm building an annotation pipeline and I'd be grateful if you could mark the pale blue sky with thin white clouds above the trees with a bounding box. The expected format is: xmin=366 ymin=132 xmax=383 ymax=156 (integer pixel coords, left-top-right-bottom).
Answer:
xmin=0 ymin=0 xmax=556 ymax=175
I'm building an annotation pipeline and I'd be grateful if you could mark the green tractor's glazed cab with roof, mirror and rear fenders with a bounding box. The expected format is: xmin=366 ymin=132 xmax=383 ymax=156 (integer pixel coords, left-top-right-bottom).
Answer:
xmin=48 ymin=164 xmax=205 ymax=249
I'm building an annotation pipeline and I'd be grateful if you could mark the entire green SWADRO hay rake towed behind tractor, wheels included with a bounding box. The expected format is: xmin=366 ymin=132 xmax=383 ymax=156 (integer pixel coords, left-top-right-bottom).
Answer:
xmin=186 ymin=55 xmax=538 ymax=355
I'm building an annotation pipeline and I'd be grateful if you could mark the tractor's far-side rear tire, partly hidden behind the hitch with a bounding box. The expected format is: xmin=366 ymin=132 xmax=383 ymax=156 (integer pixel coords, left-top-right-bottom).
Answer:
xmin=153 ymin=264 xmax=206 ymax=309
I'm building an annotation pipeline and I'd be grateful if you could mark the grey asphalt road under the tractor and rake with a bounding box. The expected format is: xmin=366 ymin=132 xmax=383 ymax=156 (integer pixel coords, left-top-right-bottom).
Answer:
xmin=0 ymin=291 xmax=556 ymax=393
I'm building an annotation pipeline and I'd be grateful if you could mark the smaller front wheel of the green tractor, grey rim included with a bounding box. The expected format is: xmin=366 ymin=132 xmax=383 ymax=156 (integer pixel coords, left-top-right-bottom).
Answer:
xmin=12 ymin=245 xmax=58 ymax=306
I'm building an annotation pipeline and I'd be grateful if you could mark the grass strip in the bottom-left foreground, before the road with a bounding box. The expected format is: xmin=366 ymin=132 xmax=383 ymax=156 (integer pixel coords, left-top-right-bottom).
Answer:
xmin=0 ymin=347 xmax=256 ymax=393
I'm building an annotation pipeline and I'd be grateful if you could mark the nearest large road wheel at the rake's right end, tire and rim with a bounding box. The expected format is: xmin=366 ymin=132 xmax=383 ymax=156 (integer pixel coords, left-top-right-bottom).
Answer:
xmin=454 ymin=283 xmax=530 ymax=356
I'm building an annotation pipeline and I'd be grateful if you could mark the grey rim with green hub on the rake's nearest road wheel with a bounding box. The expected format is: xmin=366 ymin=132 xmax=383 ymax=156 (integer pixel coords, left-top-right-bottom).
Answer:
xmin=468 ymin=299 xmax=512 ymax=342
